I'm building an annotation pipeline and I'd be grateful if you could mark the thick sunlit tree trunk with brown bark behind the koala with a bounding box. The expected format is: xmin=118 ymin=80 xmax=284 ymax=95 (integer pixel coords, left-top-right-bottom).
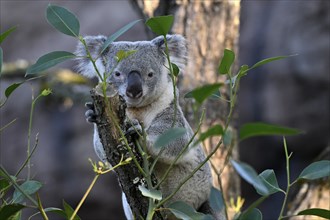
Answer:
xmin=132 ymin=0 xmax=240 ymax=218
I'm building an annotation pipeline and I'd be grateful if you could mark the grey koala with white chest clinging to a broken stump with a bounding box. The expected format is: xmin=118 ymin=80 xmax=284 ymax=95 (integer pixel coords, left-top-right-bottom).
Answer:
xmin=76 ymin=35 xmax=218 ymax=219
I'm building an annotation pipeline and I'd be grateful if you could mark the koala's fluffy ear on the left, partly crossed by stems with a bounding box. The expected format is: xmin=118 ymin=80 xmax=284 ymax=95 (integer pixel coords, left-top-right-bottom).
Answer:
xmin=75 ymin=35 xmax=107 ymax=78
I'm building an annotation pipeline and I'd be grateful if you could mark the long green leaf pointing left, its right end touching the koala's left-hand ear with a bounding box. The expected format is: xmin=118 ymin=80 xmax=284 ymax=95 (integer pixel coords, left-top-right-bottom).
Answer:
xmin=26 ymin=51 xmax=76 ymax=75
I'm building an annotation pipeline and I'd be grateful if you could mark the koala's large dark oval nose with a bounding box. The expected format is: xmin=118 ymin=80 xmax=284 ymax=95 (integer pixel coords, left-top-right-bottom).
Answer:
xmin=126 ymin=71 xmax=142 ymax=99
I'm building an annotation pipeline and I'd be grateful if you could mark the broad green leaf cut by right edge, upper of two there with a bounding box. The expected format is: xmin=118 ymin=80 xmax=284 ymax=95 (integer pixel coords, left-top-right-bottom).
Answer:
xmin=298 ymin=160 xmax=330 ymax=180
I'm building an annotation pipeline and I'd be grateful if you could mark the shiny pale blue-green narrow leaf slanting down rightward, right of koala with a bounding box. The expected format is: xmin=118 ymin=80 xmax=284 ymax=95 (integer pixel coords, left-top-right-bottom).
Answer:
xmin=230 ymin=160 xmax=269 ymax=195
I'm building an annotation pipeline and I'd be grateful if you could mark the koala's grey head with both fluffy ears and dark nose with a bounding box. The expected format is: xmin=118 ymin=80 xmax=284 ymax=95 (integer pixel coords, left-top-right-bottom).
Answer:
xmin=76 ymin=35 xmax=187 ymax=107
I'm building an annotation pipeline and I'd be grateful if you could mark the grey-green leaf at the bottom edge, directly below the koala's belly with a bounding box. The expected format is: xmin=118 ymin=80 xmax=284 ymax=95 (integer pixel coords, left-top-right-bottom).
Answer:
xmin=167 ymin=201 xmax=213 ymax=220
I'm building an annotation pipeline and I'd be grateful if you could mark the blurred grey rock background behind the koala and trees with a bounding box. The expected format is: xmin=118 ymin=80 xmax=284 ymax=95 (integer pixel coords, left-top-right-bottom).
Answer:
xmin=0 ymin=0 xmax=330 ymax=220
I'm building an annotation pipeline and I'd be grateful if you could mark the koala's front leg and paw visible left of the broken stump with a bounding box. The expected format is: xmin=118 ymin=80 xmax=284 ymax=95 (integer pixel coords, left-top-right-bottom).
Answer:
xmin=85 ymin=102 xmax=107 ymax=162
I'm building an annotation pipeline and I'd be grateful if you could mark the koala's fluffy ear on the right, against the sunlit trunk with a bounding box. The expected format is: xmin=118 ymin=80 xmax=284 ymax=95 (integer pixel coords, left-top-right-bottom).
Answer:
xmin=152 ymin=34 xmax=187 ymax=71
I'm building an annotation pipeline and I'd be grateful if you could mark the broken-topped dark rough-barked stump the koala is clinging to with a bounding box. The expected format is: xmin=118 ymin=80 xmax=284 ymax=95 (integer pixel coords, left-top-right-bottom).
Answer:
xmin=91 ymin=87 xmax=160 ymax=219
